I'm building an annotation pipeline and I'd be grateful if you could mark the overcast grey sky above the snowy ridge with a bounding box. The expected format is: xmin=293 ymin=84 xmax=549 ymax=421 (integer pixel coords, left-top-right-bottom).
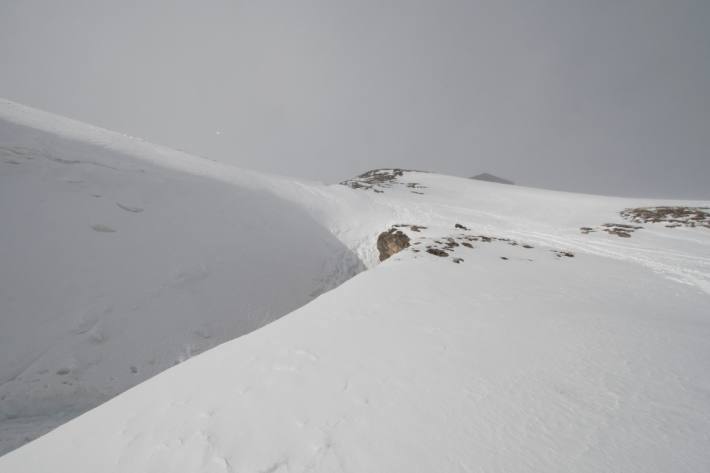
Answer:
xmin=0 ymin=0 xmax=710 ymax=199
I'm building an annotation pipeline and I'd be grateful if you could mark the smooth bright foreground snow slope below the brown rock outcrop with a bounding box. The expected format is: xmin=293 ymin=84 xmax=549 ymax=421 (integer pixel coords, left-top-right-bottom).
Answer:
xmin=5 ymin=216 xmax=710 ymax=472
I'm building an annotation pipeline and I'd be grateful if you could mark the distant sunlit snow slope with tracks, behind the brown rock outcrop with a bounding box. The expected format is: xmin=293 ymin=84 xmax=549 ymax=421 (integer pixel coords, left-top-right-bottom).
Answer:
xmin=339 ymin=166 xmax=710 ymax=293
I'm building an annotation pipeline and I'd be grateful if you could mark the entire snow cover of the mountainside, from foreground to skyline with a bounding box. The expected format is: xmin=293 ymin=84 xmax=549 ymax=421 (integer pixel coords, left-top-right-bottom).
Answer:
xmin=0 ymin=97 xmax=710 ymax=473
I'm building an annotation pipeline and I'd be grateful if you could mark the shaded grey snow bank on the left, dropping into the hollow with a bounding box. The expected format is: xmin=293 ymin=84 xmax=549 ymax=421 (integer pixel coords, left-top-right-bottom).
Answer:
xmin=0 ymin=99 xmax=364 ymax=453
